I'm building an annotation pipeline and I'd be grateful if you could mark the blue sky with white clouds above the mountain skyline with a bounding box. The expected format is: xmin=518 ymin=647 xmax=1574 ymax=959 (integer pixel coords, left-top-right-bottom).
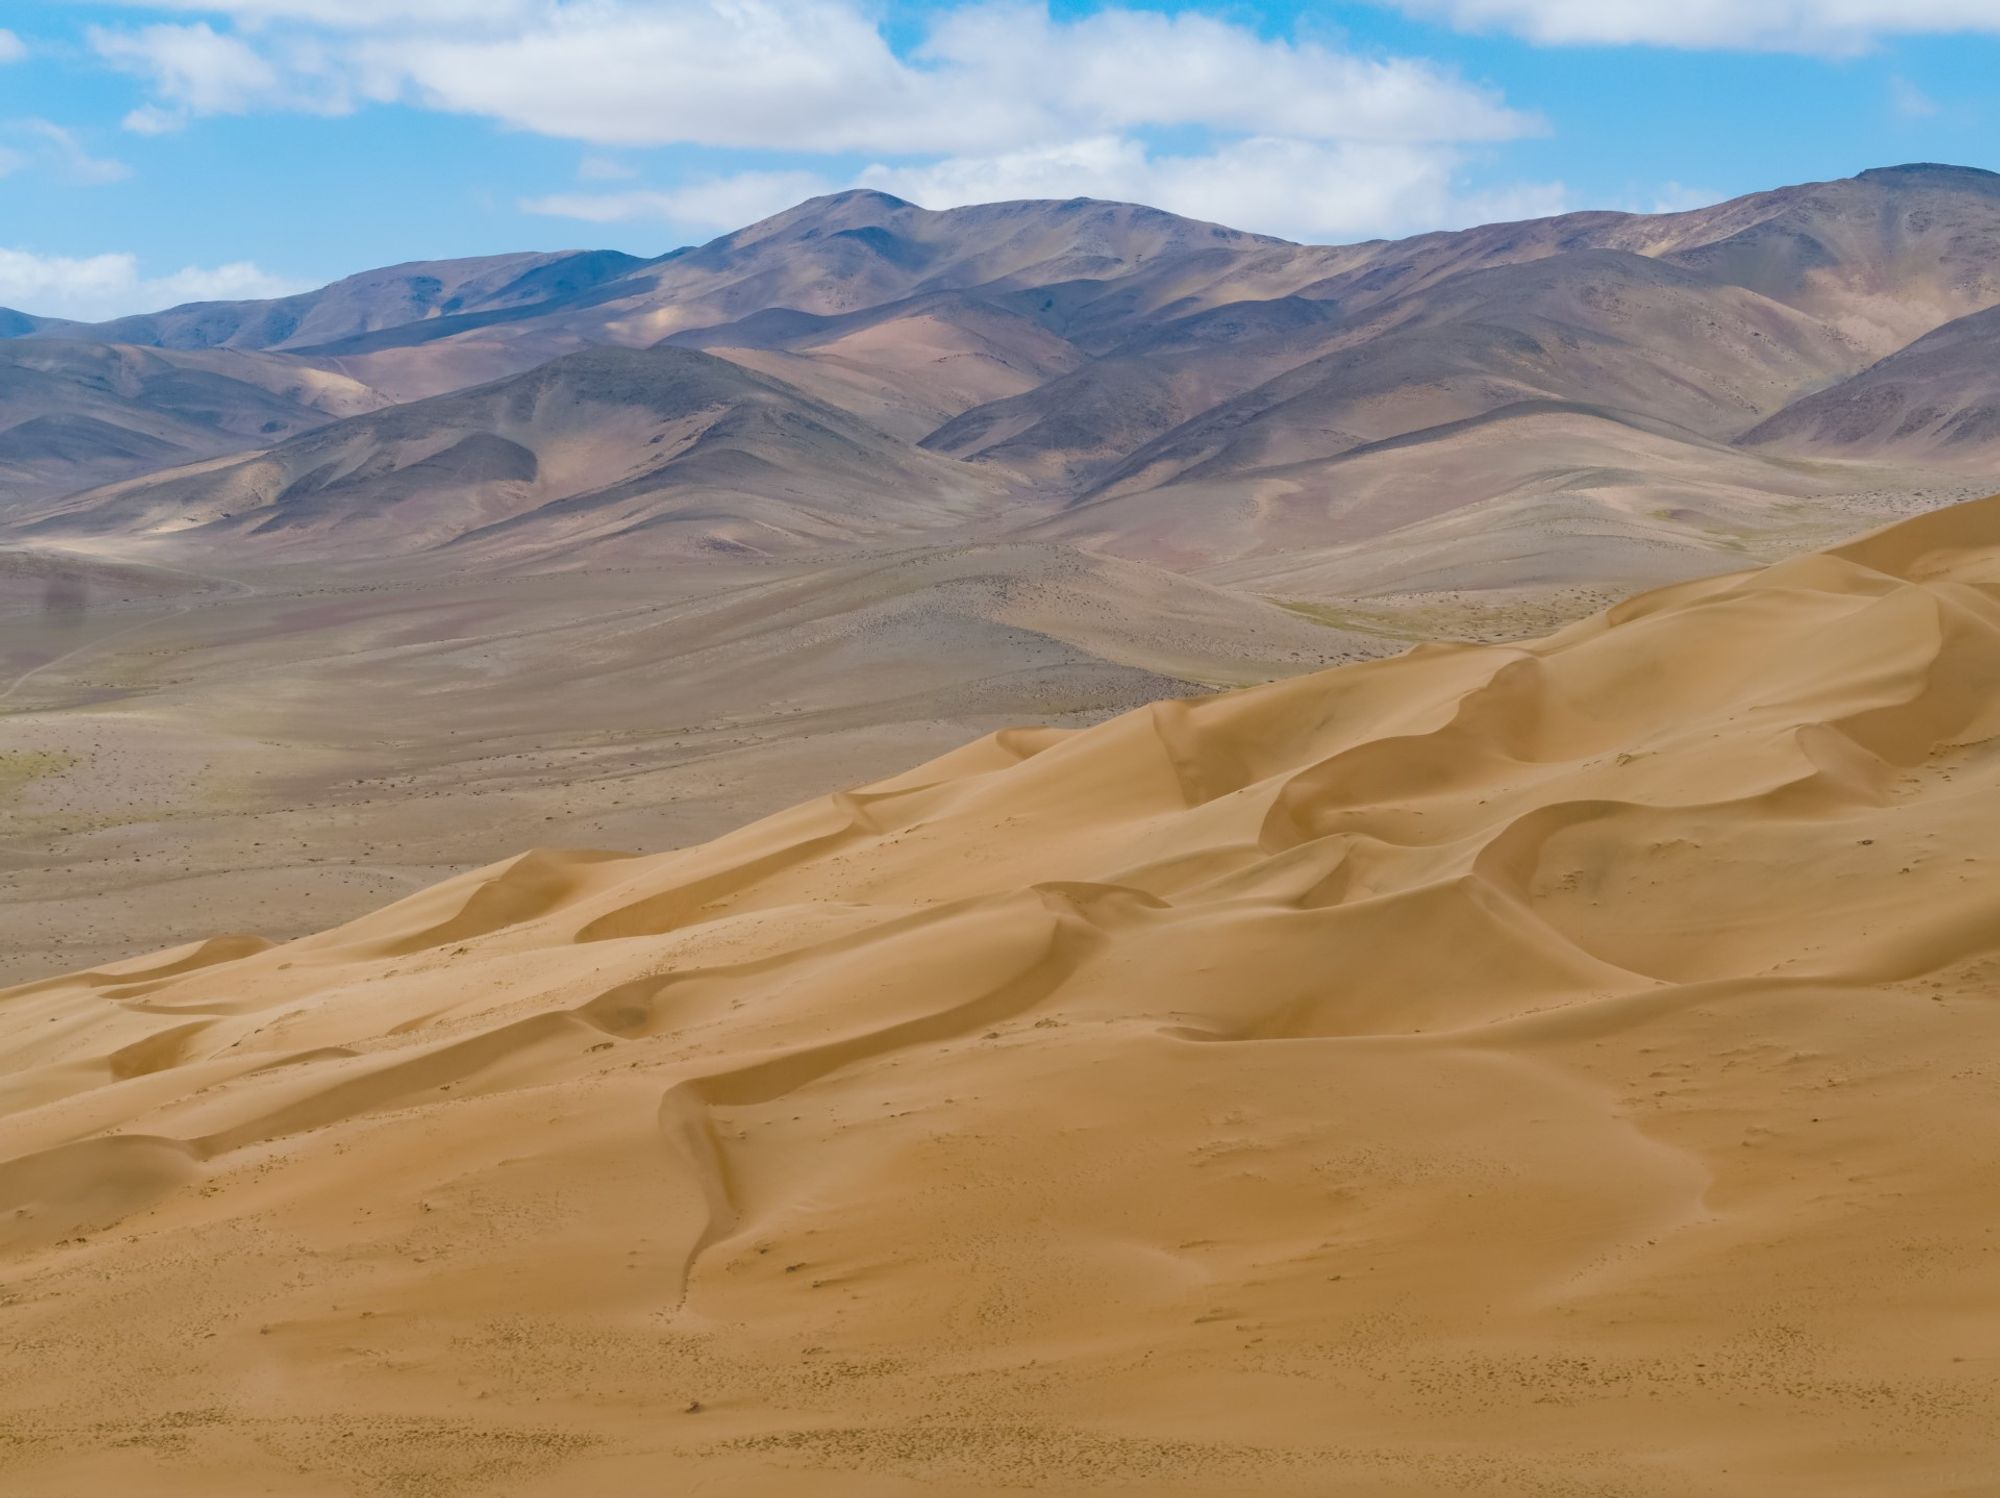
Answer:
xmin=0 ymin=0 xmax=2000 ymax=316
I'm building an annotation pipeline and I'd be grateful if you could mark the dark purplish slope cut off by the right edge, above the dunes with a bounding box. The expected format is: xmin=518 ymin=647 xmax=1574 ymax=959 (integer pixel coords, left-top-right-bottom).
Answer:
xmin=1742 ymin=306 xmax=2000 ymax=464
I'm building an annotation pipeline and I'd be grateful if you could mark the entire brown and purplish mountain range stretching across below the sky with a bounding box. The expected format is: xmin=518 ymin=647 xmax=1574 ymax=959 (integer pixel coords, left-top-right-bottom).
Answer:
xmin=0 ymin=164 xmax=2000 ymax=596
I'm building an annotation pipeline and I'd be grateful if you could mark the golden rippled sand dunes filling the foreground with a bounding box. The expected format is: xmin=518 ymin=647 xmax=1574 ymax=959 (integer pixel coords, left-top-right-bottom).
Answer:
xmin=0 ymin=498 xmax=2000 ymax=1498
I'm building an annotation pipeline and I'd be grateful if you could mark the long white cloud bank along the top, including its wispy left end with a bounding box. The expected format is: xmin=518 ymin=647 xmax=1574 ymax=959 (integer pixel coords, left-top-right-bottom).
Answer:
xmin=90 ymin=0 xmax=1540 ymax=152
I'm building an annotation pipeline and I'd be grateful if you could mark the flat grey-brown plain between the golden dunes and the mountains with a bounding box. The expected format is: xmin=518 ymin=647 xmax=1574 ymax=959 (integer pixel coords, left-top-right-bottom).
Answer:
xmin=0 ymin=546 xmax=1360 ymax=986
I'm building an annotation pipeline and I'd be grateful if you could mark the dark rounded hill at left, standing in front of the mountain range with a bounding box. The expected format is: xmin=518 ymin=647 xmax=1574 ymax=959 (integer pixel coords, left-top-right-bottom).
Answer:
xmin=19 ymin=348 xmax=994 ymax=560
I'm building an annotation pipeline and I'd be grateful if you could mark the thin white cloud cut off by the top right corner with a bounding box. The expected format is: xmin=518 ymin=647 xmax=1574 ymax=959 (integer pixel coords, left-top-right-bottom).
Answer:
xmin=1388 ymin=0 xmax=2000 ymax=54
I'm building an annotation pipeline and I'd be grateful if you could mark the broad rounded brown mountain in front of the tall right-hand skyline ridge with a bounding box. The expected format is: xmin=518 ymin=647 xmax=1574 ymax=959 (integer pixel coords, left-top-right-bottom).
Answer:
xmin=928 ymin=250 xmax=1864 ymax=496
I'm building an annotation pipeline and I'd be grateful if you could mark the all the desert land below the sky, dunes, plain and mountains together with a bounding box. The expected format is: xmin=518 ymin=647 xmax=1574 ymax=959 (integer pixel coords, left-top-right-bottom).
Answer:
xmin=0 ymin=166 xmax=2000 ymax=1498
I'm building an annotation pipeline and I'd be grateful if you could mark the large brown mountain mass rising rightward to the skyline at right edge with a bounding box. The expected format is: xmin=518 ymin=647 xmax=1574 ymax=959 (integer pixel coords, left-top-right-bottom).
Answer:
xmin=926 ymin=168 xmax=2000 ymax=526
